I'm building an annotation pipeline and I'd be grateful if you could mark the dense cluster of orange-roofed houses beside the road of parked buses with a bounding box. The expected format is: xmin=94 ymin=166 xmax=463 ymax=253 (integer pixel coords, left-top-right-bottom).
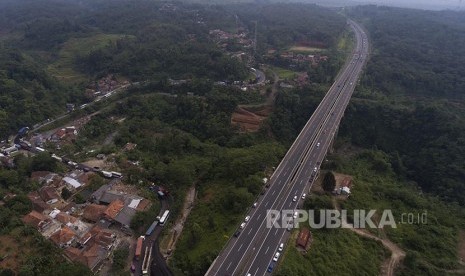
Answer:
xmin=22 ymin=170 xmax=151 ymax=271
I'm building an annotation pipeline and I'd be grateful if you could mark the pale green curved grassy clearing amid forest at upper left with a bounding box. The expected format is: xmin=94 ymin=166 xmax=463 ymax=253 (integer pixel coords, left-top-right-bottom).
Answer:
xmin=48 ymin=34 xmax=133 ymax=83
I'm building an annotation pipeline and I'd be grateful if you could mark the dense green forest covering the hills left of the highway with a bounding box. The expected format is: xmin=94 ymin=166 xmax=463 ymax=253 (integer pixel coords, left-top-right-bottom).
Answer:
xmin=0 ymin=0 xmax=345 ymax=275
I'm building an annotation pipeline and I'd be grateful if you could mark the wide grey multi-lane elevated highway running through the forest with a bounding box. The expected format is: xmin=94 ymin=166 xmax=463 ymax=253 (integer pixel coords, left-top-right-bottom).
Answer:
xmin=206 ymin=18 xmax=368 ymax=275
